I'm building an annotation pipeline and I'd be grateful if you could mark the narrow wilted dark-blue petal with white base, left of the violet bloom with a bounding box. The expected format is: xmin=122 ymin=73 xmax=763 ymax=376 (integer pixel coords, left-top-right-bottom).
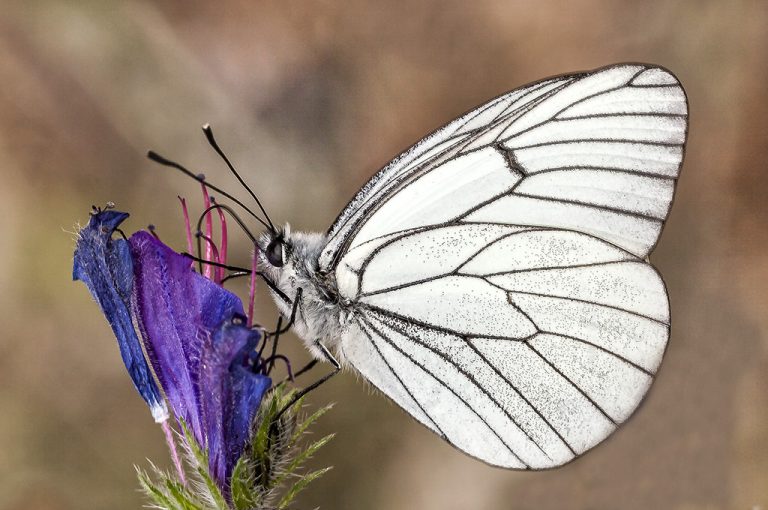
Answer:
xmin=72 ymin=210 xmax=168 ymax=422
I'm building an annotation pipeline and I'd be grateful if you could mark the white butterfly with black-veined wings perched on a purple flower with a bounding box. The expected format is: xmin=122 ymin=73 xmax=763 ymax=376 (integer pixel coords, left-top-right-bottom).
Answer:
xmin=260 ymin=64 xmax=687 ymax=469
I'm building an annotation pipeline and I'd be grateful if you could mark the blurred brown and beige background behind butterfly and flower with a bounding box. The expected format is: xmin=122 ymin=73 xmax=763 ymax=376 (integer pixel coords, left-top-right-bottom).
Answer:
xmin=0 ymin=0 xmax=768 ymax=510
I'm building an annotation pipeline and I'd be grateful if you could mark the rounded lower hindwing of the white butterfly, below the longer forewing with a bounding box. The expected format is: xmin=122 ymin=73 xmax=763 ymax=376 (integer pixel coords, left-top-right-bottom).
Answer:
xmin=341 ymin=229 xmax=669 ymax=469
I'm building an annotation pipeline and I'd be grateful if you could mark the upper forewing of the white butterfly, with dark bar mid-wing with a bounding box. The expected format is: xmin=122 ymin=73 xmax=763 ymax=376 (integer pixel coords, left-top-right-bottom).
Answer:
xmin=320 ymin=64 xmax=688 ymax=270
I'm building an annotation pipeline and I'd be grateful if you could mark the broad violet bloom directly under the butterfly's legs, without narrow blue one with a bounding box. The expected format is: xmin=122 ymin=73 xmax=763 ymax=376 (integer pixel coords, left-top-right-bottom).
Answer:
xmin=129 ymin=232 xmax=272 ymax=487
